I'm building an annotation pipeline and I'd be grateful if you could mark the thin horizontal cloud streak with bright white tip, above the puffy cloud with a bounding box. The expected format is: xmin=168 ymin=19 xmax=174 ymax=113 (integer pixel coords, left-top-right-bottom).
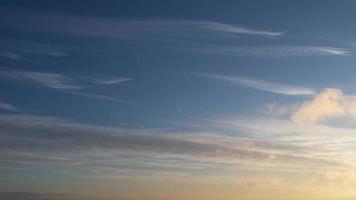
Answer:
xmin=199 ymin=46 xmax=351 ymax=58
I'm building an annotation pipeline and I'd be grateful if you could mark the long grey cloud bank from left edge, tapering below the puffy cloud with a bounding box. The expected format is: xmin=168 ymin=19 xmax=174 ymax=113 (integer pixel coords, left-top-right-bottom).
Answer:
xmin=0 ymin=116 xmax=325 ymax=172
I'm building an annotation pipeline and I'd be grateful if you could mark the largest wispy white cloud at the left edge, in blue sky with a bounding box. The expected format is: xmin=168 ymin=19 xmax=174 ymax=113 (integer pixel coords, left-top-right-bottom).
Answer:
xmin=0 ymin=70 xmax=82 ymax=90
